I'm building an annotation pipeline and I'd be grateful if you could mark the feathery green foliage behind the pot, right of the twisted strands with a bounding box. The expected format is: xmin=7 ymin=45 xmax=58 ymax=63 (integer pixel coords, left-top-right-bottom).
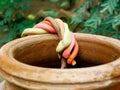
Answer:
xmin=71 ymin=0 xmax=120 ymax=39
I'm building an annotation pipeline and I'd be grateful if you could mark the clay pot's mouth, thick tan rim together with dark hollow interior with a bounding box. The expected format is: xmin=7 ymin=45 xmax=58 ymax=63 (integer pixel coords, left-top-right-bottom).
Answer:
xmin=0 ymin=33 xmax=120 ymax=83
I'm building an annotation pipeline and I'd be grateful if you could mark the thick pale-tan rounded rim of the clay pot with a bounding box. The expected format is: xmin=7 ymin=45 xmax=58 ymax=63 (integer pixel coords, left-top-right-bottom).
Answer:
xmin=0 ymin=33 xmax=120 ymax=83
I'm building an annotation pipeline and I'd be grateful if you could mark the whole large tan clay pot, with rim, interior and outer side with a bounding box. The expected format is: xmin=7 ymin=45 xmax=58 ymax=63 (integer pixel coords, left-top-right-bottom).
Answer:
xmin=0 ymin=34 xmax=120 ymax=90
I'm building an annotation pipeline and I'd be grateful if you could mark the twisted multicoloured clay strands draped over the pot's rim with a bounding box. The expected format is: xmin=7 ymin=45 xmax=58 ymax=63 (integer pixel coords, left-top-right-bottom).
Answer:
xmin=21 ymin=17 xmax=79 ymax=68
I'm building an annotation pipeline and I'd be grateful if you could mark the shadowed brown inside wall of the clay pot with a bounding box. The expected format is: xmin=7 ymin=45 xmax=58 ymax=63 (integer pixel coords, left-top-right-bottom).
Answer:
xmin=13 ymin=35 xmax=120 ymax=68
